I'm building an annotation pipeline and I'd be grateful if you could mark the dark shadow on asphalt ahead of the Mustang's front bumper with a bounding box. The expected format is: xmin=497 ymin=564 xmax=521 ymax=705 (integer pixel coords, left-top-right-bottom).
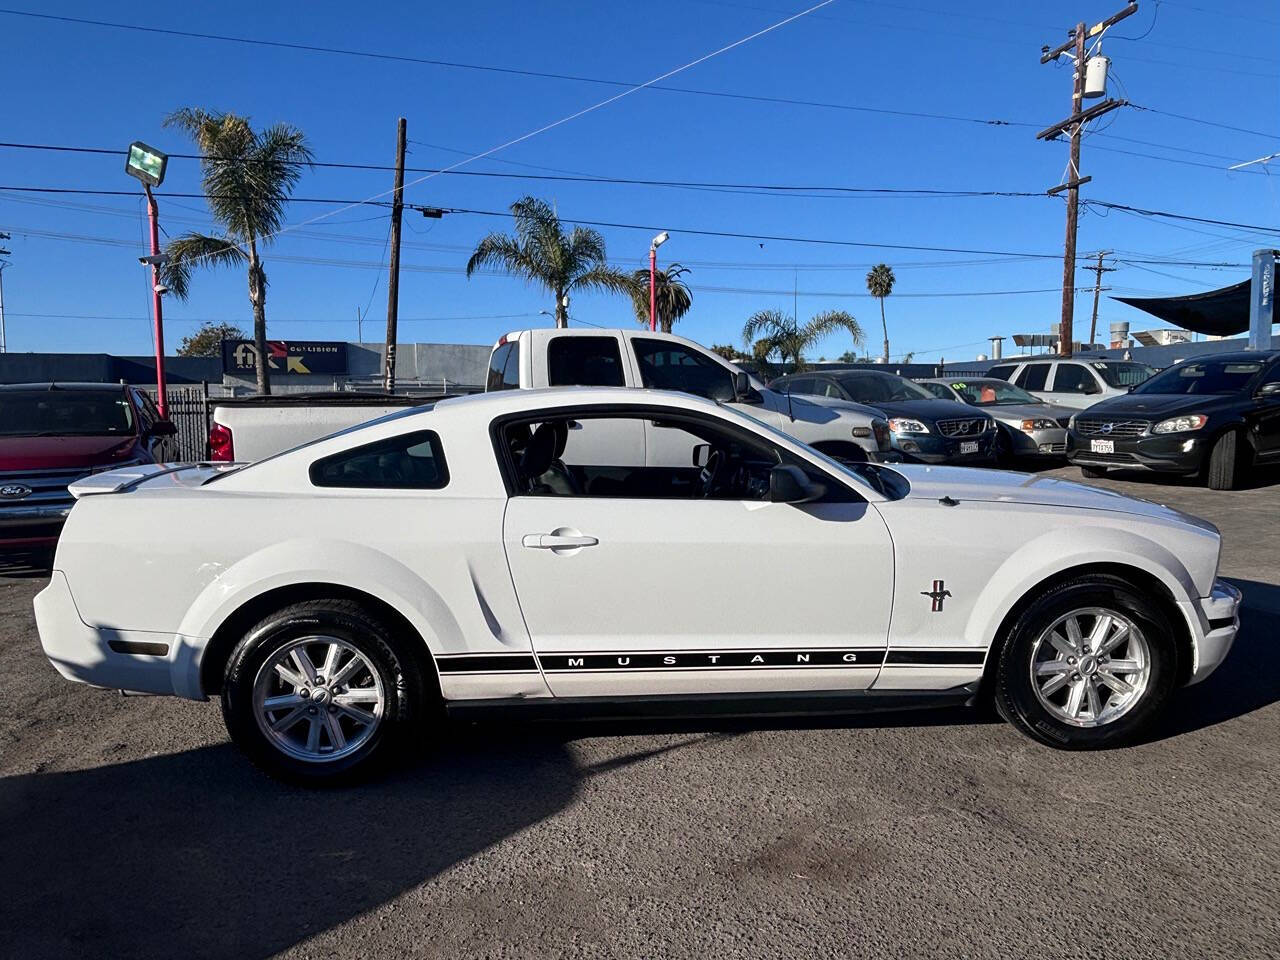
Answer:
xmin=1149 ymin=577 xmax=1280 ymax=740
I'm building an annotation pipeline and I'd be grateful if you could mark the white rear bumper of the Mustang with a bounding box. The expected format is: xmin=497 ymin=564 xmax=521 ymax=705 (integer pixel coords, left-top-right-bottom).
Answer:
xmin=35 ymin=570 xmax=187 ymax=694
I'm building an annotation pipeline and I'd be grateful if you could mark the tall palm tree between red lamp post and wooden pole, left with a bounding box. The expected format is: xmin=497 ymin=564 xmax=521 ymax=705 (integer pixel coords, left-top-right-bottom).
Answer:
xmin=161 ymin=106 xmax=312 ymax=393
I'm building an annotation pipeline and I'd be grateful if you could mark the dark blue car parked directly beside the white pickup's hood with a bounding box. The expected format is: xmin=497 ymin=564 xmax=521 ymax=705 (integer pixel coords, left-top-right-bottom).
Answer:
xmin=769 ymin=370 xmax=1000 ymax=463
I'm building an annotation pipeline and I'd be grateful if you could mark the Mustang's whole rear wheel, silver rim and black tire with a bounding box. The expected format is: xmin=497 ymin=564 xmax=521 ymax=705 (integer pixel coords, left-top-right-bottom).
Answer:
xmin=223 ymin=600 xmax=424 ymax=783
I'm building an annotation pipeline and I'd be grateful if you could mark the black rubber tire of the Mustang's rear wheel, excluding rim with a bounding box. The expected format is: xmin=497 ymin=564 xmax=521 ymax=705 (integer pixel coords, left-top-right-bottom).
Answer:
xmin=221 ymin=600 xmax=438 ymax=786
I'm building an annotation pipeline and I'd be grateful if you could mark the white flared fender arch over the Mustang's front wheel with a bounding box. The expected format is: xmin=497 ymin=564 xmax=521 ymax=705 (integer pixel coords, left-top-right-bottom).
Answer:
xmin=964 ymin=526 xmax=1199 ymax=646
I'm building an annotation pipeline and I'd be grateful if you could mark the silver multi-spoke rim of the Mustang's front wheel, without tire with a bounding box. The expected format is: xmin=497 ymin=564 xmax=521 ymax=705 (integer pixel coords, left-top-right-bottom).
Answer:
xmin=1032 ymin=607 xmax=1151 ymax=727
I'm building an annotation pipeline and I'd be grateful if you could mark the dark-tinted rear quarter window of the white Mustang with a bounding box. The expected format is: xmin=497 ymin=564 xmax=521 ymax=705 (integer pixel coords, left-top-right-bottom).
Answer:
xmin=310 ymin=430 xmax=449 ymax=490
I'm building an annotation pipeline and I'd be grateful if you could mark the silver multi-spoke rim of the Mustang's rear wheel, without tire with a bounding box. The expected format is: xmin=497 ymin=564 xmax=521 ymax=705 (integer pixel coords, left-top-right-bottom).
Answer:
xmin=253 ymin=636 xmax=387 ymax=763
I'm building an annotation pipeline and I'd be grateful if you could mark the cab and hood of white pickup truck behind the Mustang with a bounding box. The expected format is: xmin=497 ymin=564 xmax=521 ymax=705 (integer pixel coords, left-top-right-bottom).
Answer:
xmin=485 ymin=329 xmax=896 ymax=466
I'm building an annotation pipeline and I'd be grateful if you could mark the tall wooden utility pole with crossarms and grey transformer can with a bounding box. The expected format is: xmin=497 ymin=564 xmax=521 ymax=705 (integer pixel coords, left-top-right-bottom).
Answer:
xmin=1036 ymin=0 xmax=1138 ymax=357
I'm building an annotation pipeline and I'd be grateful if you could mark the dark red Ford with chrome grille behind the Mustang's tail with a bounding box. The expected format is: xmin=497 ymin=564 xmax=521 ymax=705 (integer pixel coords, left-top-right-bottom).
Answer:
xmin=0 ymin=383 xmax=178 ymax=548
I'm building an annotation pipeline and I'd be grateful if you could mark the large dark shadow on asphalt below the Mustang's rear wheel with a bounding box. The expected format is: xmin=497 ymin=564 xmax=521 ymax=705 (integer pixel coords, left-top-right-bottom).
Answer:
xmin=0 ymin=730 xmax=583 ymax=960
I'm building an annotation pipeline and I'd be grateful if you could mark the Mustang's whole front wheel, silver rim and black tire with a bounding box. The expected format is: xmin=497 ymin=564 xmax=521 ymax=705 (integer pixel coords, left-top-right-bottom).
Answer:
xmin=995 ymin=576 xmax=1178 ymax=750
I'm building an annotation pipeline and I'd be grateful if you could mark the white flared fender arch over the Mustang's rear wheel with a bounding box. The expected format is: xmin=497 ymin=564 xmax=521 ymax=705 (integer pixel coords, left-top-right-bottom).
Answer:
xmin=173 ymin=539 xmax=466 ymax=699
